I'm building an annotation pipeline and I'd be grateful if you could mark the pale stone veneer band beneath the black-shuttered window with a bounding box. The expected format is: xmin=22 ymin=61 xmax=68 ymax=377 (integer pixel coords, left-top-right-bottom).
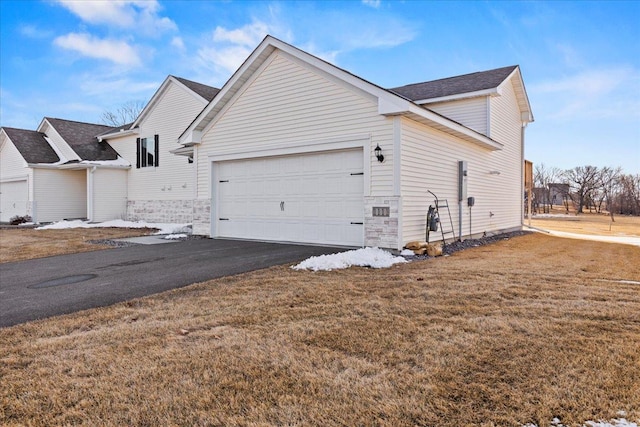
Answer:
xmin=127 ymin=200 xmax=194 ymax=224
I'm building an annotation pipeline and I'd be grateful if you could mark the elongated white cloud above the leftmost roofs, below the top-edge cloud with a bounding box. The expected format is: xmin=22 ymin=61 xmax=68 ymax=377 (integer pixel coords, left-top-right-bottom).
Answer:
xmin=53 ymin=33 xmax=142 ymax=67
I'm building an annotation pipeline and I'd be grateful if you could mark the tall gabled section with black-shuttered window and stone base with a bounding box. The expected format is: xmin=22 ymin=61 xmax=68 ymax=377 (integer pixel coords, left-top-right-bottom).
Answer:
xmin=98 ymin=76 xmax=219 ymax=223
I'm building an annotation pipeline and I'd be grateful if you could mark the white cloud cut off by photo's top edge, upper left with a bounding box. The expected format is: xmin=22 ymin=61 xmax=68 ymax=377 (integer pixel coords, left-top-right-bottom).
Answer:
xmin=58 ymin=0 xmax=178 ymax=35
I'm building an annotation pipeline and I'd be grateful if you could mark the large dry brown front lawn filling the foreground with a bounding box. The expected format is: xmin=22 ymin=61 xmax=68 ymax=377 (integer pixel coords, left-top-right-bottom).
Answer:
xmin=0 ymin=233 xmax=640 ymax=426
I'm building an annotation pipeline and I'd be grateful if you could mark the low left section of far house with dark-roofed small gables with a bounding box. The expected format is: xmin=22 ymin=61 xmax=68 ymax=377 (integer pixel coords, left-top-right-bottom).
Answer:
xmin=0 ymin=117 xmax=129 ymax=222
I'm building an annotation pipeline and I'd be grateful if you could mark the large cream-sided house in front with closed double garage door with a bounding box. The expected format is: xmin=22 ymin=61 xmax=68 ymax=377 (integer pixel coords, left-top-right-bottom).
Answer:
xmin=176 ymin=36 xmax=533 ymax=249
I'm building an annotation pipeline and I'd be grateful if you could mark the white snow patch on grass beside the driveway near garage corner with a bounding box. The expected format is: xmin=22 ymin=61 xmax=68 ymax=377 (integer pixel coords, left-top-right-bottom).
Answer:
xmin=291 ymin=248 xmax=413 ymax=271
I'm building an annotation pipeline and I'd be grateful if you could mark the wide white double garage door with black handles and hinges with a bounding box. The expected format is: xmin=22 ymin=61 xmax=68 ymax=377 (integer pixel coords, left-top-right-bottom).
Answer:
xmin=218 ymin=149 xmax=364 ymax=246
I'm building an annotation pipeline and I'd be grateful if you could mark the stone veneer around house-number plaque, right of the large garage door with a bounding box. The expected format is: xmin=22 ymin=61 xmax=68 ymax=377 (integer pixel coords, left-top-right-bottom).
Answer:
xmin=364 ymin=197 xmax=400 ymax=249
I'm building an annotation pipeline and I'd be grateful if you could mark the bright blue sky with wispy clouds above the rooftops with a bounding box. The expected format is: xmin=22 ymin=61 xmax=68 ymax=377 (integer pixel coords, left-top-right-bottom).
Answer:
xmin=0 ymin=0 xmax=640 ymax=174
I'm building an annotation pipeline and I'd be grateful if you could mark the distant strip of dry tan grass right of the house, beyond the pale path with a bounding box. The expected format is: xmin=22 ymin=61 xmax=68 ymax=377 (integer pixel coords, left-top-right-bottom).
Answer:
xmin=525 ymin=213 xmax=640 ymax=237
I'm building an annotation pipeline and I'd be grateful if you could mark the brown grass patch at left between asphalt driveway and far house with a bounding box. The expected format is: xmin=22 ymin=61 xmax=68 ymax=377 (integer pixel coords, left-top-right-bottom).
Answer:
xmin=0 ymin=228 xmax=154 ymax=263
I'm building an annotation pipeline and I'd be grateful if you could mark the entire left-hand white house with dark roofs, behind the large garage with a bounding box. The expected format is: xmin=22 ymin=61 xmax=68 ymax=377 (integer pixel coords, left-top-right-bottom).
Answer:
xmin=0 ymin=76 xmax=218 ymax=226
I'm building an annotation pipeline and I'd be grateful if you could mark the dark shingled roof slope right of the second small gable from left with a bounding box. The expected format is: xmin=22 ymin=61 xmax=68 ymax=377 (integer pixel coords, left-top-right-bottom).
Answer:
xmin=45 ymin=117 xmax=118 ymax=161
